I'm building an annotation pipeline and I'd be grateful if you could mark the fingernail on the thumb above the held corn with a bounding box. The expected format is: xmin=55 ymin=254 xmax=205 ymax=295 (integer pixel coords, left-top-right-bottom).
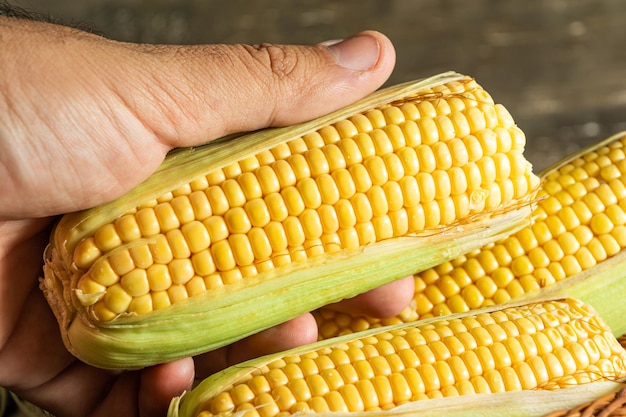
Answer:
xmin=325 ymin=35 xmax=380 ymax=71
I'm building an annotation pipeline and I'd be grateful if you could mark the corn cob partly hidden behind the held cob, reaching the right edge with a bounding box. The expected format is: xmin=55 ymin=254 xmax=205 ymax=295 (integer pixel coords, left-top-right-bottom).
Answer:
xmin=315 ymin=133 xmax=626 ymax=338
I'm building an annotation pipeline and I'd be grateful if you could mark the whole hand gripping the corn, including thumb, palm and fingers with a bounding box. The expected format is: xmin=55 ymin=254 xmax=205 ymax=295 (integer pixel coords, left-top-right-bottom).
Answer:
xmin=0 ymin=17 xmax=413 ymax=417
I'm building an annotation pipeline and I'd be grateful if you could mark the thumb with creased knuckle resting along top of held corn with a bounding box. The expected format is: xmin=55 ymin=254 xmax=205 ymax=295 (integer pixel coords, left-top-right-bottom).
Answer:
xmin=122 ymin=31 xmax=395 ymax=147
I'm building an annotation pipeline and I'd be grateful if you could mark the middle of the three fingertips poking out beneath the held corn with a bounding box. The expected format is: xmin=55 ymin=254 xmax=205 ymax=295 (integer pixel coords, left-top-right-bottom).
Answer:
xmin=195 ymin=314 xmax=317 ymax=378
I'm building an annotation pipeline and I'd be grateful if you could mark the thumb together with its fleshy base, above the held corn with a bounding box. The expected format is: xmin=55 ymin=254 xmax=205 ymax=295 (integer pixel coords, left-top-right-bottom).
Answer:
xmin=0 ymin=19 xmax=395 ymax=218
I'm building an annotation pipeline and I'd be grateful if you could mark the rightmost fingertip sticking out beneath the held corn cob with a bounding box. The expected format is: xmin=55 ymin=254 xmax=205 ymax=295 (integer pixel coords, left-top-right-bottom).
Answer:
xmin=326 ymin=276 xmax=415 ymax=318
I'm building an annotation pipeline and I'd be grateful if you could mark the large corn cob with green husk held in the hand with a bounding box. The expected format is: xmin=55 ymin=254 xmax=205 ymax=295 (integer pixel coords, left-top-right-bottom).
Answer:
xmin=43 ymin=73 xmax=538 ymax=367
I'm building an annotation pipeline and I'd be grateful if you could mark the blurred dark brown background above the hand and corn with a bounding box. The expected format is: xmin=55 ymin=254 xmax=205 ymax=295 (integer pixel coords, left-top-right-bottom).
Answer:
xmin=10 ymin=0 xmax=626 ymax=170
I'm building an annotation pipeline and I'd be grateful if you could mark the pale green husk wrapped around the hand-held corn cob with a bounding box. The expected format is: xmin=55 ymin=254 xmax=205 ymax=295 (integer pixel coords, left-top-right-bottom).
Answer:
xmin=42 ymin=72 xmax=531 ymax=368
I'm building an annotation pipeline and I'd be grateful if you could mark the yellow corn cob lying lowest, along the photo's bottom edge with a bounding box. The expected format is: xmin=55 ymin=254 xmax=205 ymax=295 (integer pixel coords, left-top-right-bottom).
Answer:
xmin=170 ymin=299 xmax=626 ymax=417
